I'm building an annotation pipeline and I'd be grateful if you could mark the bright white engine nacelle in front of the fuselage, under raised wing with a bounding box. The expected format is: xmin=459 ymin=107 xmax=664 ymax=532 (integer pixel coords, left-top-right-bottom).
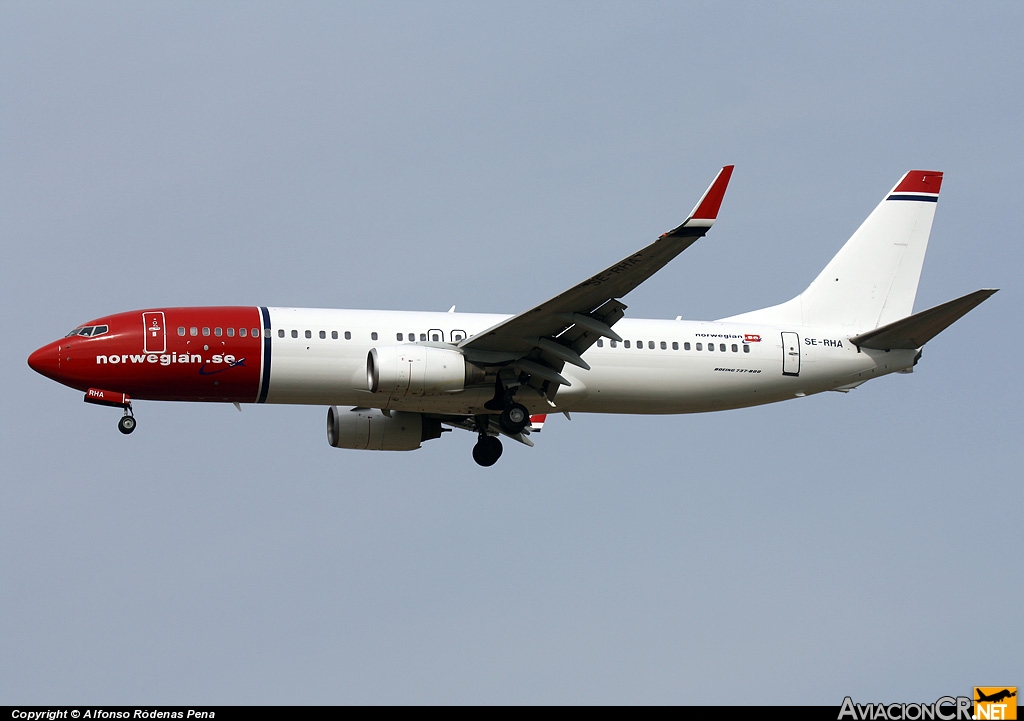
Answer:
xmin=367 ymin=345 xmax=484 ymax=398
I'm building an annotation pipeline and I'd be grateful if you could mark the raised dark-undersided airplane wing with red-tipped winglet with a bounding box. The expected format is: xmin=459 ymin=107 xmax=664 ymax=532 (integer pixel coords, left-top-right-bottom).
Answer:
xmin=459 ymin=165 xmax=733 ymax=395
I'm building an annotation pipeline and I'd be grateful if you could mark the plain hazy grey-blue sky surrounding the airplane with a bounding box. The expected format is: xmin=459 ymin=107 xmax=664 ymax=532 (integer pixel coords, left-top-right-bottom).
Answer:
xmin=0 ymin=2 xmax=1024 ymax=705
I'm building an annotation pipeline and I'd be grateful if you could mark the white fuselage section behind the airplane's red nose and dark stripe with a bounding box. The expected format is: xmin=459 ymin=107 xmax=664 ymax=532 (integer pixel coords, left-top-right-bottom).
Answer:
xmin=266 ymin=308 xmax=916 ymax=414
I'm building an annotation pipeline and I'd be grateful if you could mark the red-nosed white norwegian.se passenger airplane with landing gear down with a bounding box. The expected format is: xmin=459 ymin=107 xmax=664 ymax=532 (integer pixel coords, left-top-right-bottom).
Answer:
xmin=29 ymin=165 xmax=998 ymax=466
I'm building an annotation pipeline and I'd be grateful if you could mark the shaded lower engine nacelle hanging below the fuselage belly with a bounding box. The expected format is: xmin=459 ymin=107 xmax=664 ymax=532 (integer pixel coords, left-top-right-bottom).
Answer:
xmin=327 ymin=406 xmax=441 ymax=451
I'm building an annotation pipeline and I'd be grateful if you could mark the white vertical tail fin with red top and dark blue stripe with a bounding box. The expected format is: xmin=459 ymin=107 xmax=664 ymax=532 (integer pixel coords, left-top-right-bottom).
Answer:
xmin=723 ymin=170 xmax=942 ymax=334
